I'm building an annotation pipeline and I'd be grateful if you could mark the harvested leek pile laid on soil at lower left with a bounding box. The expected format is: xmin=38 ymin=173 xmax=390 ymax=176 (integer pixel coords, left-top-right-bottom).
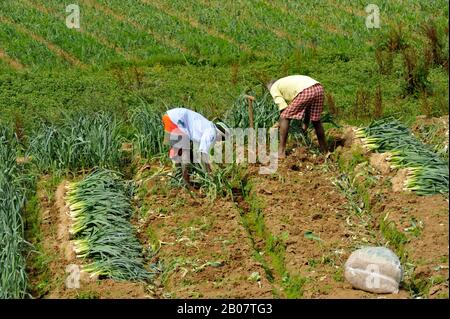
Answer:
xmin=66 ymin=169 xmax=154 ymax=282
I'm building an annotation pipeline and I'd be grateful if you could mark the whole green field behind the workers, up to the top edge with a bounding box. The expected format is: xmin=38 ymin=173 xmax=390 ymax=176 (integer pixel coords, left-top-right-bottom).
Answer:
xmin=0 ymin=0 xmax=448 ymax=129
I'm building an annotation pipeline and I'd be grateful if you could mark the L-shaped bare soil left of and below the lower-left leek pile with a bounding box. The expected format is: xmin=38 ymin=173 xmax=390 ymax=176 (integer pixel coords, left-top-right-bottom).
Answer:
xmin=31 ymin=177 xmax=150 ymax=299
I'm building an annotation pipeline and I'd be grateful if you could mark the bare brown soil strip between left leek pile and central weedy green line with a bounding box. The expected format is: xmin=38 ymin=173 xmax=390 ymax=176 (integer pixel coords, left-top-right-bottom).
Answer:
xmin=139 ymin=181 xmax=272 ymax=298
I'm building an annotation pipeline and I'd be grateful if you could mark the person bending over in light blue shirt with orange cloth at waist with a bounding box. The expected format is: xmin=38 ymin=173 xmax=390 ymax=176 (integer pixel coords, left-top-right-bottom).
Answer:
xmin=162 ymin=108 xmax=225 ymax=186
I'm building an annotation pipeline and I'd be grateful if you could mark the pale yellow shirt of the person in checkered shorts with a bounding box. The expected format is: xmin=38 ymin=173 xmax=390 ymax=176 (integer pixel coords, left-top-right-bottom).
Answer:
xmin=270 ymin=75 xmax=319 ymax=111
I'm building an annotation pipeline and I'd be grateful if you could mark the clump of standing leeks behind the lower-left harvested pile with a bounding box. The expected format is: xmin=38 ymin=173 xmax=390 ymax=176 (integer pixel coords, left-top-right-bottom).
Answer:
xmin=27 ymin=113 xmax=122 ymax=172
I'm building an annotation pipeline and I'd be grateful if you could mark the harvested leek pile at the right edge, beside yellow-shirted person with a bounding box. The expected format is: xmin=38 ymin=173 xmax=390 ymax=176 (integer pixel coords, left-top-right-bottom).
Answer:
xmin=356 ymin=118 xmax=449 ymax=195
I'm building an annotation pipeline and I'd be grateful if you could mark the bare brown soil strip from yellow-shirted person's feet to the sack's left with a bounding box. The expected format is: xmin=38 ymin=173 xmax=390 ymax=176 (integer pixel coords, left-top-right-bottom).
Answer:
xmin=250 ymin=148 xmax=404 ymax=298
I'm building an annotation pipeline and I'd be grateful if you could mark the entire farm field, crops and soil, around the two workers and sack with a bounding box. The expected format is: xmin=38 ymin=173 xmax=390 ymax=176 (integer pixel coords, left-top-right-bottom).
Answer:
xmin=0 ymin=0 xmax=449 ymax=298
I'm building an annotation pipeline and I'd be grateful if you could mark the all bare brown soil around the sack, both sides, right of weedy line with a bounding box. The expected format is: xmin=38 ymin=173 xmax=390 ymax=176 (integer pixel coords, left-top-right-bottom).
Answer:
xmin=248 ymin=136 xmax=449 ymax=298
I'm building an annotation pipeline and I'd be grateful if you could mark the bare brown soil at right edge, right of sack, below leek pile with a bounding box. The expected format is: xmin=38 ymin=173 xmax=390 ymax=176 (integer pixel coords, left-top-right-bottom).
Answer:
xmin=372 ymin=178 xmax=449 ymax=298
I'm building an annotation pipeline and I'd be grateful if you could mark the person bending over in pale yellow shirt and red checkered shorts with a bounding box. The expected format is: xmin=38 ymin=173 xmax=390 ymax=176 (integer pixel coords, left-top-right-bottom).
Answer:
xmin=267 ymin=75 xmax=327 ymax=158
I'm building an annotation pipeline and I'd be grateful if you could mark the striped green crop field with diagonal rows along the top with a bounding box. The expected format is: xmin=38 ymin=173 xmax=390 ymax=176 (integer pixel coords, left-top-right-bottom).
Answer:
xmin=4 ymin=0 xmax=448 ymax=70
